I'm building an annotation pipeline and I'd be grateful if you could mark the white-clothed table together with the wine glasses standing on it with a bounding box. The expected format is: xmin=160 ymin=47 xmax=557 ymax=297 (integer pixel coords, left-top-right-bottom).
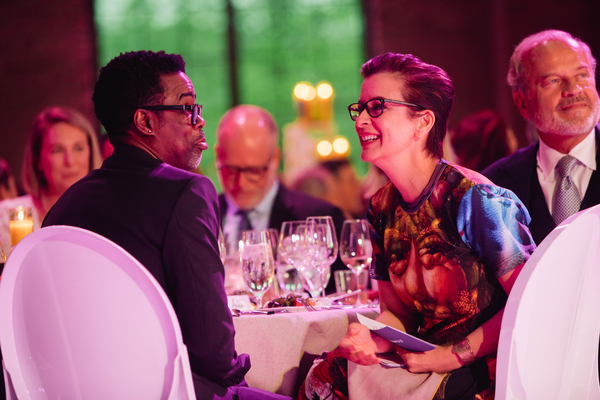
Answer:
xmin=221 ymin=216 xmax=379 ymax=397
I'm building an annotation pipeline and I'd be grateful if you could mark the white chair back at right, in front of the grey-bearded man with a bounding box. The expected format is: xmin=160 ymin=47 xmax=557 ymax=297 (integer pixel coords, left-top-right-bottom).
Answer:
xmin=496 ymin=206 xmax=600 ymax=400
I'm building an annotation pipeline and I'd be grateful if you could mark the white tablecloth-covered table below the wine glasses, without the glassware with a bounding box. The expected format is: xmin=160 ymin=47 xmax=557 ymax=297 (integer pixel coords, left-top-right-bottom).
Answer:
xmin=233 ymin=306 xmax=379 ymax=398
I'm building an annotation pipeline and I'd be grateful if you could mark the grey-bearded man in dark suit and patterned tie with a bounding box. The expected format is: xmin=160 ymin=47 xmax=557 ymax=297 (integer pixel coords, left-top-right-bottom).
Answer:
xmin=483 ymin=30 xmax=600 ymax=244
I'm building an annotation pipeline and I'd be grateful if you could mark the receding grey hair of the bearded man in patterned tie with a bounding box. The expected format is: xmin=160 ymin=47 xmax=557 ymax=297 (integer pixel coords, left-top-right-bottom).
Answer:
xmin=506 ymin=29 xmax=596 ymax=93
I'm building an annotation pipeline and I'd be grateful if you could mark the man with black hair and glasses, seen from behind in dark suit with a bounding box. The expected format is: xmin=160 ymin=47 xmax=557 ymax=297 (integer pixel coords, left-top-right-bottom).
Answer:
xmin=44 ymin=51 xmax=283 ymax=399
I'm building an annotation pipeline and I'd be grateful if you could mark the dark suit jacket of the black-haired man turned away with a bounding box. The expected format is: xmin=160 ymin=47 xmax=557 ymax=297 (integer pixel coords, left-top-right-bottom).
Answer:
xmin=43 ymin=145 xmax=250 ymax=399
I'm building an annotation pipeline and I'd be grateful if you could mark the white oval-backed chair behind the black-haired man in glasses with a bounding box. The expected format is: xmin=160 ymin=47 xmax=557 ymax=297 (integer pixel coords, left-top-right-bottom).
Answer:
xmin=0 ymin=226 xmax=196 ymax=400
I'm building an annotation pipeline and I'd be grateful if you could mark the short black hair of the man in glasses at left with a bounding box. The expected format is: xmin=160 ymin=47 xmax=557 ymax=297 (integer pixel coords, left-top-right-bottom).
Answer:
xmin=92 ymin=50 xmax=185 ymax=137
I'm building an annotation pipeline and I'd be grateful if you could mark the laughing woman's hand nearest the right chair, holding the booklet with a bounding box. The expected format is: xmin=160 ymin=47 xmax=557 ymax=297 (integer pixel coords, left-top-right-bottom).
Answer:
xmin=396 ymin=346 xmax=462 ymax=374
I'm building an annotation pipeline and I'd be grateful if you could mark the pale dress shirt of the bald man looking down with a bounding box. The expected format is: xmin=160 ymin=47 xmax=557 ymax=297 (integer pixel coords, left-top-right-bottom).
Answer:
xmin=223 ymin=181 xmax=279 ymax=254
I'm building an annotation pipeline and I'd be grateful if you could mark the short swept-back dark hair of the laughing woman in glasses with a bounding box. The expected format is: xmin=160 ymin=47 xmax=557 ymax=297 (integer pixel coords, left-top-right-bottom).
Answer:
xmin=360 ymin=53 xmax=454 ymax=158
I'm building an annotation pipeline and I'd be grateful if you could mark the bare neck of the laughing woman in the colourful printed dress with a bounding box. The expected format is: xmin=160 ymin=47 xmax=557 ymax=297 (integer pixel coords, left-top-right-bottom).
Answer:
xmin=380 ymin=156 xmax=439 ymax=204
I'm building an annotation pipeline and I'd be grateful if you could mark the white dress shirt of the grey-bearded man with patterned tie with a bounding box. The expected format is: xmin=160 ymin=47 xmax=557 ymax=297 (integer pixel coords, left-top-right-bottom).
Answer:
xmin=537 ymin=129 xmax=596 ymax=215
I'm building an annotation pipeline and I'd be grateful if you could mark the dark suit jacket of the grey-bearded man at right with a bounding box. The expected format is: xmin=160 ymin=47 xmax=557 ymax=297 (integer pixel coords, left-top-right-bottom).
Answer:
xmin=482 ymin=127 xmax=600 ymax=245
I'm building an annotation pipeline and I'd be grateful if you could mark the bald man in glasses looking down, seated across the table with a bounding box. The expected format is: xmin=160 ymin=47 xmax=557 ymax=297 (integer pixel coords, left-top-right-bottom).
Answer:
xmin=215 ymin=105 xmax=346 ymax=292
